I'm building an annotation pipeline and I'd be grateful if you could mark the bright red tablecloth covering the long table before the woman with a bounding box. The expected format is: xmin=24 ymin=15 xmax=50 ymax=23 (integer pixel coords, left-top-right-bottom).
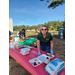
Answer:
xmin=9 ymin=47 xmax=65 ymax=75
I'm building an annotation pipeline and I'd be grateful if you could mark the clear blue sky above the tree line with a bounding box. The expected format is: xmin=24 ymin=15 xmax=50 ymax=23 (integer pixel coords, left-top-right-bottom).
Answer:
xmin=9 ymin=0 xmax=65 ymax=26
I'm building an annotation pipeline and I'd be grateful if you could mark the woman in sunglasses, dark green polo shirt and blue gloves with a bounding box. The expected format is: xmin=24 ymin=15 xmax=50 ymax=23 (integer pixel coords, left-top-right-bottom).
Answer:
xmin=37 ymin=25 xmax=53 ymax=56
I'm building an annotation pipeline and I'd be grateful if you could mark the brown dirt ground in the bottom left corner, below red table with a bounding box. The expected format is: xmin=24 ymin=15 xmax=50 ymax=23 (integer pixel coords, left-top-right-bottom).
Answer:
xmin=9 ymin=58 xmax=31 ymax=75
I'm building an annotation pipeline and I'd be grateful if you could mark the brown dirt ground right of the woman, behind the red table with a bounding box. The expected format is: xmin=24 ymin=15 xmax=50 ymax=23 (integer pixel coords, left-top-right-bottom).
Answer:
xmin=53 ymin=38 xmax=65 ymax=60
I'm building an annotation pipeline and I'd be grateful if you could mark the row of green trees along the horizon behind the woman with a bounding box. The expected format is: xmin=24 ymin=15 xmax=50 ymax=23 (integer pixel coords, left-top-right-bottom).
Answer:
xmin=13 ymin=20 xmax=65 ymax=31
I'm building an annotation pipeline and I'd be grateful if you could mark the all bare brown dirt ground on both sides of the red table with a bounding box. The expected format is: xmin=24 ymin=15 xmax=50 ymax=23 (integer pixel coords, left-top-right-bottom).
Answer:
xmin=9 ymin=38 xmax=65 ymax=75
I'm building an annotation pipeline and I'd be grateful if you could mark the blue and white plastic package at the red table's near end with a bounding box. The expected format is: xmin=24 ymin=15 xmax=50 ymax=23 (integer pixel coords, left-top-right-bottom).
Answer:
xmin=45 ymin=58 xmax=64 ymax=75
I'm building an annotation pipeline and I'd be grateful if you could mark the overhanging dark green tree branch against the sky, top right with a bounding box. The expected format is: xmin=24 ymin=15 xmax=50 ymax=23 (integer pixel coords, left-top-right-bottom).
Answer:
xmin=40 ymin=0 xmax=65 ymax=9
